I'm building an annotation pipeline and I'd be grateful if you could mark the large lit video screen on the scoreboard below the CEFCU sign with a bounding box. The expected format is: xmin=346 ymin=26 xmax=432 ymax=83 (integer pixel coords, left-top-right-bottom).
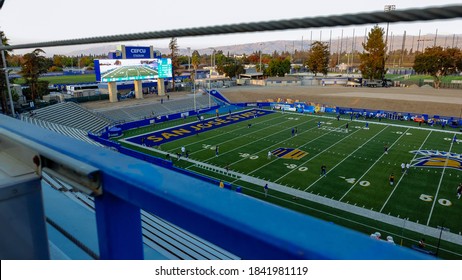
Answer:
xmin=95 ymin=58 xmax=172 ymax=82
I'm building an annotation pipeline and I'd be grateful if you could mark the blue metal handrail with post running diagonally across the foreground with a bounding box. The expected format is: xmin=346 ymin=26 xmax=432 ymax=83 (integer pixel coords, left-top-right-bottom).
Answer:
xmin=0 ymin=115 xmax=433 ymax=259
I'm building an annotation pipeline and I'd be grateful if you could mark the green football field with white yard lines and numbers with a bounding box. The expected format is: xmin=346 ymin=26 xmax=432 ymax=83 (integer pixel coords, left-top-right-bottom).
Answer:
xmin=115 ymin=108 xmax=462 ymax=259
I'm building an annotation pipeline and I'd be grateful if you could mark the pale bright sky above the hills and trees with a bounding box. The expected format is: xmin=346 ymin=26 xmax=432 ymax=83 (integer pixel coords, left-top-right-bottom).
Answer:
xmin=0 ymin=0 xmax=462 ymax=53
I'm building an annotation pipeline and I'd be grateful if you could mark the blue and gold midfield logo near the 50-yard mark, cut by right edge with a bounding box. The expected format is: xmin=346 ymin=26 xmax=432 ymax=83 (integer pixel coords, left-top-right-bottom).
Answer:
xmin=410 ymin=150 xmax=462 ymax=170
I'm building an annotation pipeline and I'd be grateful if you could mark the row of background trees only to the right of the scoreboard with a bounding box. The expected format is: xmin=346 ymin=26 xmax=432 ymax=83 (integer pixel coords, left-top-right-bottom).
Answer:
xmin=169 ymin=25 xmax=462 ymax=88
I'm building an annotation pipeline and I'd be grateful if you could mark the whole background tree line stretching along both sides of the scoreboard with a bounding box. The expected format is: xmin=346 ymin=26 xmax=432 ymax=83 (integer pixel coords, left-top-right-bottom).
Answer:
xmin=0 ymin=25 xmax=462 ymax=115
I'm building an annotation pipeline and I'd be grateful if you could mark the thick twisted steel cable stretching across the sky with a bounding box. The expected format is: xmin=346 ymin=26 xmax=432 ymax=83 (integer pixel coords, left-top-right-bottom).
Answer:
xmin=0 ymin=5 xmax=462 ymax=50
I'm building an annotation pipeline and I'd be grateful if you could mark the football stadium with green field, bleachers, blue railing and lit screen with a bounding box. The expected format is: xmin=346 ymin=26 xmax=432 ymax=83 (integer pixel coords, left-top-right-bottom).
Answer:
xmin=0 ymin=4 xmax=462 ymax=260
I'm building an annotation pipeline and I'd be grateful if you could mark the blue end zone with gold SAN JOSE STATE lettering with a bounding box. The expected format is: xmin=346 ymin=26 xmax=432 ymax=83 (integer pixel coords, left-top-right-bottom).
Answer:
xmin=125 ymin=109 xmax=274 ymax=147
